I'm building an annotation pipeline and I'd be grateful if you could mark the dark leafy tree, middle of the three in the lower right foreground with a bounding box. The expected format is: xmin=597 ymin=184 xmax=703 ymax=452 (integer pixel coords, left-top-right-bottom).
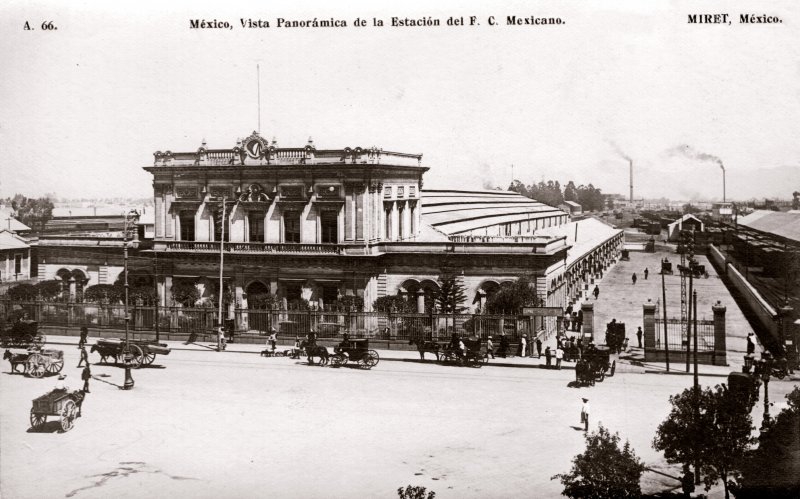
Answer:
xmin=653 ymin=385 xmax=755 ymax=499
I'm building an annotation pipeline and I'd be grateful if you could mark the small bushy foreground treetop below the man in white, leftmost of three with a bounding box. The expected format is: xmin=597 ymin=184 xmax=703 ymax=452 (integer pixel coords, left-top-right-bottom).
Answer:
xmin=552 ymin=425 xmax=645 ymax=499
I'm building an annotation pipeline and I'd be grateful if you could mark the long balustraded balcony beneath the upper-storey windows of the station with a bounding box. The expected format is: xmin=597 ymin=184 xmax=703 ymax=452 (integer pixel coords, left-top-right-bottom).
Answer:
xmin=154 ymin=241 xmax=344 ymax=255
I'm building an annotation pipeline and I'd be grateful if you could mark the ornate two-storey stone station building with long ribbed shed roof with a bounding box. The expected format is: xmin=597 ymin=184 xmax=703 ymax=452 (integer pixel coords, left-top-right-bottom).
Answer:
xmin=32 ymin=132 xmax=622 ymax=324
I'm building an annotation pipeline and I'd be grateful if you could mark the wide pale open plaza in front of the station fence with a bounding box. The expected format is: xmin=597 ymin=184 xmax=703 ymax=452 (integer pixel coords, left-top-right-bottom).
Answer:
xmin=0 ymin=338 xmax=793 ymax=498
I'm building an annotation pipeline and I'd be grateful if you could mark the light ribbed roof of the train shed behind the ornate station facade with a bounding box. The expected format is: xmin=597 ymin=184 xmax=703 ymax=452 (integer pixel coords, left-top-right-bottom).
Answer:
xmin=421 ymin=190 xmax=564 ymax=235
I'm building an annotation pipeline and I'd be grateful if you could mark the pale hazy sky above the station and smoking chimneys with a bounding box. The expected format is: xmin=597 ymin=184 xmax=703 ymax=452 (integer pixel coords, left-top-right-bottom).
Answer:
xmin=0 ymin=0 xmax=800 ymax=201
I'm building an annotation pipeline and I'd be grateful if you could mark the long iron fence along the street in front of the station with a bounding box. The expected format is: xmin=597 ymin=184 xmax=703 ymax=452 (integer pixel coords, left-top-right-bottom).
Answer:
xmin=0 ymin=298 xmax=557 ymax=341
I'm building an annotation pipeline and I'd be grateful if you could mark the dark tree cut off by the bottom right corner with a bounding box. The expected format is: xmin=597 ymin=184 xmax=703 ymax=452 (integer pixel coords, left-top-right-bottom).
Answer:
xmin=732 ymin=387 xmax=800 ymax=499
